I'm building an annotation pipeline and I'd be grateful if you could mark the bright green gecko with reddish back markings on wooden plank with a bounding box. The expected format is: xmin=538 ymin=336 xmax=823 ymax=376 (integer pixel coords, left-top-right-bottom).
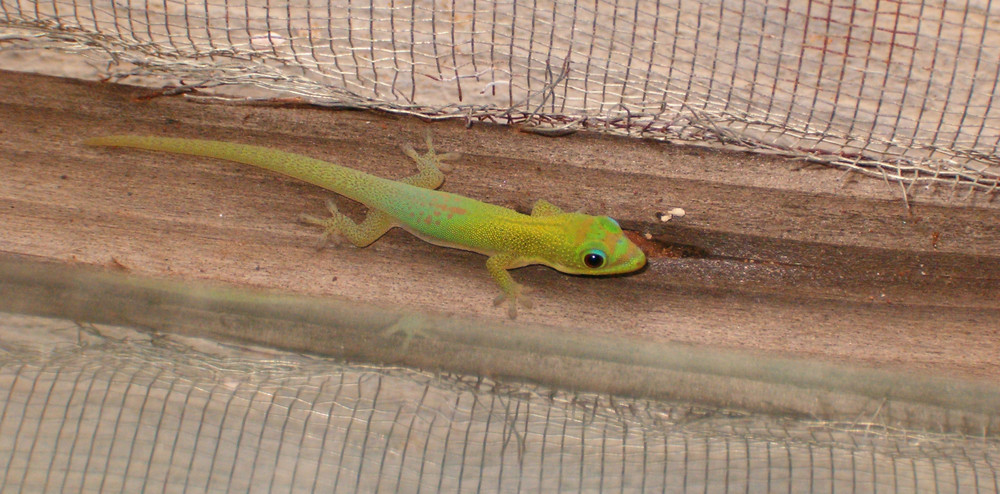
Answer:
xmin=84 ymin=135 xmax=646 ymax=319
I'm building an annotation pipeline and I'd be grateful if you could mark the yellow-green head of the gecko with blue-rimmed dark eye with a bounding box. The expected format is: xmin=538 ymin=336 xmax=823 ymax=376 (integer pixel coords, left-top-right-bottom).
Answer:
xmin=552 ymin=213 xmax=646 ymax=275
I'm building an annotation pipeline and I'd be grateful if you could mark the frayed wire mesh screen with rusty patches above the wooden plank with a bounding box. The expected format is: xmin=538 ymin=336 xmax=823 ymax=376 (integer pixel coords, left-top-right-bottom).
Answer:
xmin=0 ymin=0 xmax=1000 ymax=192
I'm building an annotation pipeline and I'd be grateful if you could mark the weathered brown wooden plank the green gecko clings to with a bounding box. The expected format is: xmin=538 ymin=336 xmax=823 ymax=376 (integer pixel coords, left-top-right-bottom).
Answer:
xmin=0 ymin=72 xmax=1000 ymax=378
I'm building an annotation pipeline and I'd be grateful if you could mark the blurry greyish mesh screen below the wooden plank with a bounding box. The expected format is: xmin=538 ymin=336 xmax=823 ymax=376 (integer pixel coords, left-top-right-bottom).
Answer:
xmin=0 ymin=316 xmax=1000 ymax=492
